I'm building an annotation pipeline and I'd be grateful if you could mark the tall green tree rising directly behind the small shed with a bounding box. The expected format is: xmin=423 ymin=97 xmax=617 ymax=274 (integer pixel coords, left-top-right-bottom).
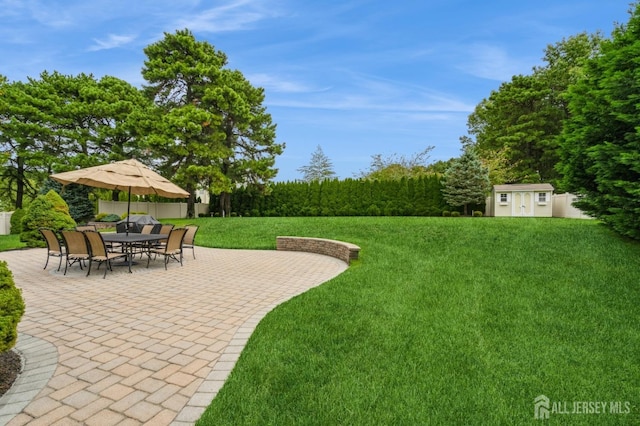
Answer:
xmin=467 ymin=33 xmax=602 ymax=183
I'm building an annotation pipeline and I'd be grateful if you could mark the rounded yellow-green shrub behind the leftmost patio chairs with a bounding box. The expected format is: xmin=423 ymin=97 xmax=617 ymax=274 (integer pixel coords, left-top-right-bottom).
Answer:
xmin=20 ymin=190 xmax=76 ymax=247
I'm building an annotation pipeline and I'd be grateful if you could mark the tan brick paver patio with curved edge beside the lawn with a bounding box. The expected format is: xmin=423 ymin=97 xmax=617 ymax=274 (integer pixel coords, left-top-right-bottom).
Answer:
xmin=0 ymin=247 xmax=347 ymax=426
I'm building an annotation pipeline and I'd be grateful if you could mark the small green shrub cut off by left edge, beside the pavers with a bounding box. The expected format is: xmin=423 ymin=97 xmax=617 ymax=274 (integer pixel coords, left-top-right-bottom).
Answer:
xmin=0 ymin=261 xmax=24 ymax=352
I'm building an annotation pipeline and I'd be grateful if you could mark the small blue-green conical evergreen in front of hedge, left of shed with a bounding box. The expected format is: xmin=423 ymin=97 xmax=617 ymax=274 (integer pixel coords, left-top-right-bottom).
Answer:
xmin=442 ymin=147 xmax=491 ymax=216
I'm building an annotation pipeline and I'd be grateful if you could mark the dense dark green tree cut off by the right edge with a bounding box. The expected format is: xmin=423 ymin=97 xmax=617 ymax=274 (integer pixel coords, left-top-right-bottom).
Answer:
xmin=558 ymin=3 xmax=640 ymax=239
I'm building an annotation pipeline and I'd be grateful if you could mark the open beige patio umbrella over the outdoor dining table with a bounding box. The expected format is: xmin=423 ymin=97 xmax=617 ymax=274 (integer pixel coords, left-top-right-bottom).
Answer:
xmin=50 ymin=159 xmax=189 ymax=232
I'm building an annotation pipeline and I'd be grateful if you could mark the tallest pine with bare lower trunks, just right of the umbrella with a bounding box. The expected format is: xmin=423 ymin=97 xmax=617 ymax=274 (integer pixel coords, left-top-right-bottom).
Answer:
xmin=140 ymin=30 xmax=284 ymax=215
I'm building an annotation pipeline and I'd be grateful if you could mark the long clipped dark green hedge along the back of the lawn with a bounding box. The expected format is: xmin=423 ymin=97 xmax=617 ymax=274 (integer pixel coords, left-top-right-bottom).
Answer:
xmin=211 ymin=175 xmax=455 ymax=217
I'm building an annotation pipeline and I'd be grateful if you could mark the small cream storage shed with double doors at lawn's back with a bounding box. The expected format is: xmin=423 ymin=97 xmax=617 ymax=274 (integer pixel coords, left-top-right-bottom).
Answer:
xmin=487 ymin=183 xmax=553 ymax=217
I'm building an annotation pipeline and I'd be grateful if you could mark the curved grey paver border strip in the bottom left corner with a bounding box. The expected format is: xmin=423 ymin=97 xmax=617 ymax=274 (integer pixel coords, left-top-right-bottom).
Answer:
xmin=0 ymin=333 xmax=58 ymax=424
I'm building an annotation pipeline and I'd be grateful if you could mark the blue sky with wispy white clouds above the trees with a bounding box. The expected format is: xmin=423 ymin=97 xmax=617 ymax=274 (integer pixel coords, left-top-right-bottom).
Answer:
xmin=0 ymin=0 xmax=630 ymax=180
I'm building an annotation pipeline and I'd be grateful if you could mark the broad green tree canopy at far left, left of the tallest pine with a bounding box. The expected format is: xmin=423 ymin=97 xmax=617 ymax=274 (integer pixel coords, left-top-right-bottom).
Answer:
xmin=0 ymin=72 xmax=145 ymax=208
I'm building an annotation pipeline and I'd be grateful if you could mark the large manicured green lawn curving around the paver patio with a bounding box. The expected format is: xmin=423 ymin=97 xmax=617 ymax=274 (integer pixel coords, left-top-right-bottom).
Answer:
xmin=182 ymin=217 xmax=640 ymax=425
